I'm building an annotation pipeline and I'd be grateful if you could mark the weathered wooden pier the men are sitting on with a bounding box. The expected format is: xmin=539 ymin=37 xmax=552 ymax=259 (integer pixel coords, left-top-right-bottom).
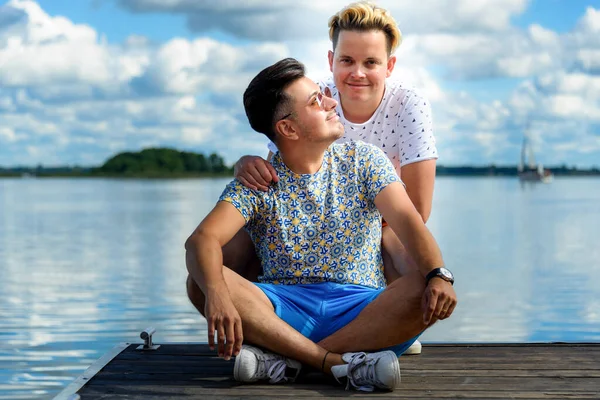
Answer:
xmin=56 ymin=343 xmax=600 ymax=400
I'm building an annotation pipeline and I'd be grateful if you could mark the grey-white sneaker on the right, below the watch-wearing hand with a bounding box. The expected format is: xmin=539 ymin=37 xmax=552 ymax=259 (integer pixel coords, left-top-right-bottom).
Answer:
xmin=331 ymin=350 xmax=400 ymax=392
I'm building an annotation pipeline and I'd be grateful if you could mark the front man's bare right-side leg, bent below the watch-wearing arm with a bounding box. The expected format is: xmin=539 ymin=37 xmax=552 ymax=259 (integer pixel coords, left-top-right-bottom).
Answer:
xmin=318 ymin=271 xmax=427 ymax=353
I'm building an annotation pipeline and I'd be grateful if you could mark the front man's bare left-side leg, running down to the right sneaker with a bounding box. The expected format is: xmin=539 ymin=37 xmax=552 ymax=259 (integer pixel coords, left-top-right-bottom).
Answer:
xmin=187 ymin=267 xmax=344 ymax=373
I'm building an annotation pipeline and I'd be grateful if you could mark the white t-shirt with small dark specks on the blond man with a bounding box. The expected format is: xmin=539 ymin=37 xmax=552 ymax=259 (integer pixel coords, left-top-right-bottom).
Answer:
xmin=269 ymin=77 xmax=438 ymax=176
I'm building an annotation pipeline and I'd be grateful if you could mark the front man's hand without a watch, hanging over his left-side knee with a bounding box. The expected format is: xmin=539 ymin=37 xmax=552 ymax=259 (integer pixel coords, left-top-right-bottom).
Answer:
xmin=204 ymin=289 xmax=244 ymax=360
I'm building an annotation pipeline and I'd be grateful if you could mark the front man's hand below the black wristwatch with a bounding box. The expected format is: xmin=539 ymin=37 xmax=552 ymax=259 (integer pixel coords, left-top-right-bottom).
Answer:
xmin=422 ymin=277 xmax=456 ymax=326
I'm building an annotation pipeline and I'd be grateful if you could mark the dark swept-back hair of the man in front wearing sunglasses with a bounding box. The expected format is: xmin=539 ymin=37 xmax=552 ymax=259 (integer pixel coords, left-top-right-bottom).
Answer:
xmin=244 ymin=58 xmax=305 ymax=141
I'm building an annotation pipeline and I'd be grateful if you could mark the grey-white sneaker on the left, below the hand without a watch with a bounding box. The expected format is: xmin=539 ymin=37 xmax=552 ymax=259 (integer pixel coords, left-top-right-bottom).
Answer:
xmin=233 ymin=344 xmax=302 ymax=383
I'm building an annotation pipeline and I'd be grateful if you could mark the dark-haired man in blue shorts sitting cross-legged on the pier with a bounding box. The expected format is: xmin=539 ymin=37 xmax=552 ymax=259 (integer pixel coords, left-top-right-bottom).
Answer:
xmin=185 ymin=58 xmax=456 ymax=390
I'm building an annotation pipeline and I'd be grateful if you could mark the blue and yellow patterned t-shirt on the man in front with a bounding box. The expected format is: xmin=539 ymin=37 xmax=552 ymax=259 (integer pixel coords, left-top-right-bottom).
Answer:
xmin=219 ymin=142 xmax=400 ymax=288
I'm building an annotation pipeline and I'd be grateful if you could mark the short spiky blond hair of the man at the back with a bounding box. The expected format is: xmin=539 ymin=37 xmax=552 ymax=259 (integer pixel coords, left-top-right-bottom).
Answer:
xmin=329 ymin=1 xmax=402 ymax=55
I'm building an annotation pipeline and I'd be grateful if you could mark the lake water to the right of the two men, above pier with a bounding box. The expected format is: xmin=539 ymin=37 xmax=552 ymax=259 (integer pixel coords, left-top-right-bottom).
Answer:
xmin=423 ymin=179 xmax=600 ymax=342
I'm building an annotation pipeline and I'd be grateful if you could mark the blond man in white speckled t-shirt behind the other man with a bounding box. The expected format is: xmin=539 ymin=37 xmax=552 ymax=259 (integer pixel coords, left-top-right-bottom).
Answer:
xmin=232 ymin=1 xmax=438 ymax=354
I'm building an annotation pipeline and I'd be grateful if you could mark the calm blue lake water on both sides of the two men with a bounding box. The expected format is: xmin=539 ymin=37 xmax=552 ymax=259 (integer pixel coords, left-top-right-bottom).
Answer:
xmin=0 ymin=177 xmax=600 ymax=399
